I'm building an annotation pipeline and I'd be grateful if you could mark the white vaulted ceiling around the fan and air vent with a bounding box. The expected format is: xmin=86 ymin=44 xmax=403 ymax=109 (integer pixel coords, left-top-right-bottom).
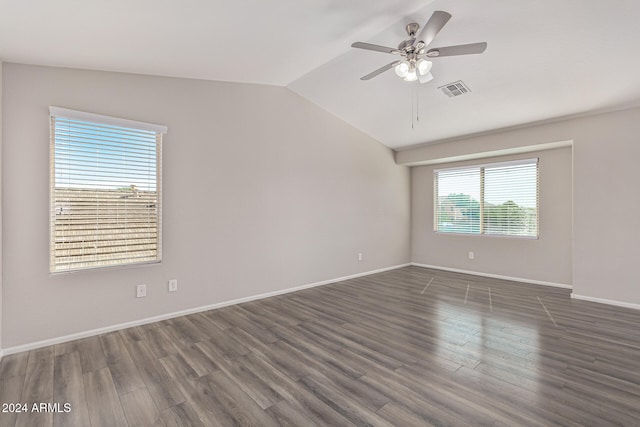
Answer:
xmin=0 ymin=0 xmax=640 ymax=149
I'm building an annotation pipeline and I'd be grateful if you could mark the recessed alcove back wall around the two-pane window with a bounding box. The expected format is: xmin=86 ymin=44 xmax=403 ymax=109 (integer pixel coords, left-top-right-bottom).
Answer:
xmin=411 ymin=147 xmax=572 ymax=285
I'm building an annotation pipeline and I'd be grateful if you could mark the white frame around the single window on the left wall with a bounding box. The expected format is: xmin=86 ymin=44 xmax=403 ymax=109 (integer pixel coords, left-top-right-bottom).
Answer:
xmin=49 ymin=106 xmax=167 ymax=274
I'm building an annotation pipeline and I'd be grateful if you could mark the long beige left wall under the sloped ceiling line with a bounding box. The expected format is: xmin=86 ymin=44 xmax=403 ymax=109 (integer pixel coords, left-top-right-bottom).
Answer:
xmin=2 ymin=64 xmax=410 ymax=348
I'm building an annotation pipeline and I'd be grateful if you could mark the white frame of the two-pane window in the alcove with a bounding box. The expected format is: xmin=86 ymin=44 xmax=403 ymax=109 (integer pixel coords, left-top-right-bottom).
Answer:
xmin=433 ymin=157 xmax=540 ymax=239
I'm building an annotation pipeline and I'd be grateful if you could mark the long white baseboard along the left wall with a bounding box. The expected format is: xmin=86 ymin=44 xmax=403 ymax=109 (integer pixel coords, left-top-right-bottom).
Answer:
xmin=0 ymin=263 xmax=411 ymax=358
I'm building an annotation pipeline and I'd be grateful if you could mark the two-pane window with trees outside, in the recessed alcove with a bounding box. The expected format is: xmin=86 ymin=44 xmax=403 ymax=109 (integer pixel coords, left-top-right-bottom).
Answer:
xmin=434 ymin=159 xmax=538 ymax=237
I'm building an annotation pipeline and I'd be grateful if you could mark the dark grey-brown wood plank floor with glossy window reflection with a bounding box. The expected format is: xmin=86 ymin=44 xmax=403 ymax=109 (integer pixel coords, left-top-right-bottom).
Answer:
xmin=0 ymin=267 xmax=640 ymax=427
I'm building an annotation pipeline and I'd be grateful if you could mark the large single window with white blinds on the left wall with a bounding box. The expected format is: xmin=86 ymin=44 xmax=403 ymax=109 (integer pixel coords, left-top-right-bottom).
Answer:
xmin=50 ymin=107 xmax=167 ymax=273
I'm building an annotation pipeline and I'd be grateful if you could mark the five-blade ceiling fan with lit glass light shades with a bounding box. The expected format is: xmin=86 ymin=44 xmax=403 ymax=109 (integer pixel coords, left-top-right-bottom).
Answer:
xmin=351 ymin=10 xmax=487 ymax=83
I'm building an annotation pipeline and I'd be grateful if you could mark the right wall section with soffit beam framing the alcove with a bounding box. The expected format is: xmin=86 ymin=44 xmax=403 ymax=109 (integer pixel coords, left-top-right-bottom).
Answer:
xmin=396 ymin=108 xmax=640 ymax=304
